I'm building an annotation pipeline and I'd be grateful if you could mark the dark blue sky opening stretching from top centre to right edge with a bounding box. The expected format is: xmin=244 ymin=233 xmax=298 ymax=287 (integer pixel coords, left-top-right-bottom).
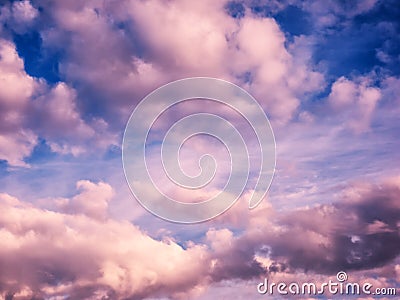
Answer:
xmin=239 ymin=0 xmax=400 ymax=77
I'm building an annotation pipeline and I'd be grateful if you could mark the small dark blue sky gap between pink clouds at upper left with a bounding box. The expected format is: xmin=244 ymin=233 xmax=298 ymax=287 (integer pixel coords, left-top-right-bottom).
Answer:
xmin=13 ymin=31 xmax=61 ymax=83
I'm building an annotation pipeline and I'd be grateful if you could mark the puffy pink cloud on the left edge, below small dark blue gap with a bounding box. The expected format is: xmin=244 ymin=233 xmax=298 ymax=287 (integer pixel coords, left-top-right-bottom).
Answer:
xmin=0 ymin=39 xmax=116 ymax=166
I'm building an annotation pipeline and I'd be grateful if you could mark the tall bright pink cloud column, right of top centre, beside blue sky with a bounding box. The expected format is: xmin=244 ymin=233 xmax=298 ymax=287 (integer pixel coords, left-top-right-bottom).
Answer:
xmin=233 ymin=18 xmax=299 ymax=122
